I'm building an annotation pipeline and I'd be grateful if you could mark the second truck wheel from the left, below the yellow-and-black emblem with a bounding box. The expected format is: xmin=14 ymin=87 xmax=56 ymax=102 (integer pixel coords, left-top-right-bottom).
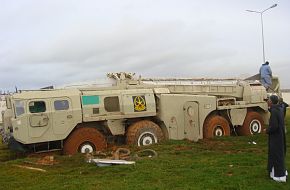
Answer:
xmin=126 ymin=120 xmax=164 ymax=146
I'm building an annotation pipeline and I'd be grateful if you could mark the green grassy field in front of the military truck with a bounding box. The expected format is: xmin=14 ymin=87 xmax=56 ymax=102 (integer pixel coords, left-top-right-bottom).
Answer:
xmin=0 ymin=109 xmax=290 ymax=190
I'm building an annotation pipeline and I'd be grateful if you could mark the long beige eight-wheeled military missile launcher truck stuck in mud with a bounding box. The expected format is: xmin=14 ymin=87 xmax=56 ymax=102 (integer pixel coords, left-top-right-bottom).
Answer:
xmin=2 ymin=73 xmax=268 ymax=154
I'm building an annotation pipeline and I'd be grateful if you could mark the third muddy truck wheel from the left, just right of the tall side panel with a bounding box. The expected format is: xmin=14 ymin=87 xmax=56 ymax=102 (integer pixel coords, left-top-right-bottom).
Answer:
xmin=203 ymin=115 xmax=230 ymax=139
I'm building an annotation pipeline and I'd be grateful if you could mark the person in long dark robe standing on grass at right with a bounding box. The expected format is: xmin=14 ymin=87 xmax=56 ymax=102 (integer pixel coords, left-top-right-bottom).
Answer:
xmin=266 ymin=95 xmax=287 ymax=182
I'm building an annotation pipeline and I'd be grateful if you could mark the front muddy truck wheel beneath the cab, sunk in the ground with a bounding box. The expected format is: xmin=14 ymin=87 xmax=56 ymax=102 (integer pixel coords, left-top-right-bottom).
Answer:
xmin=63 ymin=127 xmax=107 ymax=155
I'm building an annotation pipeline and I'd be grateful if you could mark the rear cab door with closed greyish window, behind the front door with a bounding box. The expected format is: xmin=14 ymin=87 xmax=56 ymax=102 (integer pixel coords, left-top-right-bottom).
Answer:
xmin=51 ymin=97 xmax=74 ymax=135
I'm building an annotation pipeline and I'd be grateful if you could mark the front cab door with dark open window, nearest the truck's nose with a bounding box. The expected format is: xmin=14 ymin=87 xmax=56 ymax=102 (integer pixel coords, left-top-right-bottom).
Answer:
xmin=28 ymin=99 xmax=52 ymax=137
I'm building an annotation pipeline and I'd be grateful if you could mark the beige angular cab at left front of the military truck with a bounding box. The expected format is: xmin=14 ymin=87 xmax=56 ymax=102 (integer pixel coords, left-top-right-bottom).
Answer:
xmin=4 ymin=89 xmax=82 ymax=149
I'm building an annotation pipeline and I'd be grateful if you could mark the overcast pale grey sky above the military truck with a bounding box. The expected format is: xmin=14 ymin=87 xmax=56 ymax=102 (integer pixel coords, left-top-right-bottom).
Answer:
xmin=0 ymin=0 xmax=290 ymax=90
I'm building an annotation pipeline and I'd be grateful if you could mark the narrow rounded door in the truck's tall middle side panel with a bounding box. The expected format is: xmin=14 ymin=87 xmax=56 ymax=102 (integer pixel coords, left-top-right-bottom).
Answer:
xmin=183 ymin=102 xmax=200 ymax=141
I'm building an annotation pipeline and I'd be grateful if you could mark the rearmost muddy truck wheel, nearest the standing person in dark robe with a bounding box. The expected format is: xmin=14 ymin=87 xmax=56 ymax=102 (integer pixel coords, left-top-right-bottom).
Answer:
xmin=237 ymin=111 xmax=264 ymax=135
